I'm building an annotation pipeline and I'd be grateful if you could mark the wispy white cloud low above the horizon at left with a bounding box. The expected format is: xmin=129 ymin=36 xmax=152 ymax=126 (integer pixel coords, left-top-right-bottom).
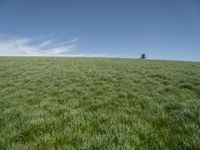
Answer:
xmin=0 ymin=34 xmax=79 ymax=56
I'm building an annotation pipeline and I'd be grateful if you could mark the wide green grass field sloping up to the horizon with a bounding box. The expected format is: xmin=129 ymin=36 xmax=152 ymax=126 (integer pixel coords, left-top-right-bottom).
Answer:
xmin=0 ymin=57 xmax=200 ymax=150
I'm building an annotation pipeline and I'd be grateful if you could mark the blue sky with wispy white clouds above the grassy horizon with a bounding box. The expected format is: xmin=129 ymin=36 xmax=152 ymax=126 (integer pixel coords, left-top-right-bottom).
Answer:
xmin=0 ymin=0 xmax=200 ymax=61
